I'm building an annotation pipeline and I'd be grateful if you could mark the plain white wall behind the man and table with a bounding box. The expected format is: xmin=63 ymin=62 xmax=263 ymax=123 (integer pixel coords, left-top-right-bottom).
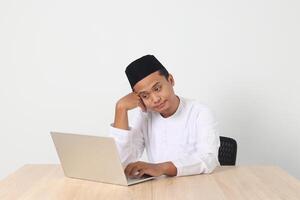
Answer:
xmin=0 ymin=0 xmax=300 ymax=179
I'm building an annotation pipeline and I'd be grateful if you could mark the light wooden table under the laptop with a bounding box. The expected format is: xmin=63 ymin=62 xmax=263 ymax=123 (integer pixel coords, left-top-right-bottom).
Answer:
xmin=0 ymin=165 xmax=300 ymax=200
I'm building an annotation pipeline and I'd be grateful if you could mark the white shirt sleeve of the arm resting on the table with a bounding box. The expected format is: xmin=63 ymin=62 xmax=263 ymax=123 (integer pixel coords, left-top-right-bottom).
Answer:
xmin=172 ymin=108 xmax=220 ymax=176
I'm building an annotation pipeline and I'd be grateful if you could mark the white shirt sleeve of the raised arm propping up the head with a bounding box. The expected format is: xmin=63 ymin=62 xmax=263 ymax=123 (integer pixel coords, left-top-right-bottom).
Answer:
xmin=109 ymin=108 xmax=147 ymax=167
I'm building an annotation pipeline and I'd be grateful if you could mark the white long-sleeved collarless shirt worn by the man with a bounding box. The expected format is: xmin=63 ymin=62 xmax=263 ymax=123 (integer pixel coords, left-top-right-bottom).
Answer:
xmin=109 ymin=97 xmax=220 ymax=176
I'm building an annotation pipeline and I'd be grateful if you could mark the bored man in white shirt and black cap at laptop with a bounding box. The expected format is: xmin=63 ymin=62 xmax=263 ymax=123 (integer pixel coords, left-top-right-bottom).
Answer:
xmin=110 ymin=55 xmax=220 ymax=178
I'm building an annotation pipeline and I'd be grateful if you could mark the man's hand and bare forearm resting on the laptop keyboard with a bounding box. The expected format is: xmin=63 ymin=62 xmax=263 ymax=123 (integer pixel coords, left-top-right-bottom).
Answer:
xmin=125 ymin=161 xmax=177 ymax=178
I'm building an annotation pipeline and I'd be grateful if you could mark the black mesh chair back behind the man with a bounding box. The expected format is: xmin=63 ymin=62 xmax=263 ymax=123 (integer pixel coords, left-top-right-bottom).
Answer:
xmin=218 ymin=136 xmax=237 ymax=165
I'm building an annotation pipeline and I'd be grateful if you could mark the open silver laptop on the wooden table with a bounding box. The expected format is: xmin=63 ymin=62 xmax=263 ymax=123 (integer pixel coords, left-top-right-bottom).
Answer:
xmin=51 ymin=132 xmax=154 ymax=186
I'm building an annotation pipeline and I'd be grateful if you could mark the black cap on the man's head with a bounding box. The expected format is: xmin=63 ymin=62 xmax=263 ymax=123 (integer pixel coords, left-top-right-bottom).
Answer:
xmin=125 ymin=55 xmax=168 ymax=89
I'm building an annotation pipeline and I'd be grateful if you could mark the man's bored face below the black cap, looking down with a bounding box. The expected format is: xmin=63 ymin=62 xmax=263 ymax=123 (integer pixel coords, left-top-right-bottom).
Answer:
xmin=133 ymin=71 xmax=176 ymax=113
